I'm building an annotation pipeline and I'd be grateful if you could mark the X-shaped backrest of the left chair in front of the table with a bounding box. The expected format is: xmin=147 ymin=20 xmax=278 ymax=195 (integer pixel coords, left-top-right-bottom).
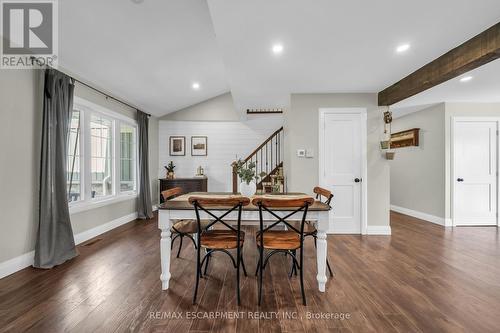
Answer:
xmin=188 ymin=195 xmax=250 ymax=232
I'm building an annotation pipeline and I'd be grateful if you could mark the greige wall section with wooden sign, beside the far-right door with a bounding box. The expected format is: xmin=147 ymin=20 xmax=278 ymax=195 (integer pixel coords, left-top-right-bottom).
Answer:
xmin=390 ymin=103 xmax=445 ymax=219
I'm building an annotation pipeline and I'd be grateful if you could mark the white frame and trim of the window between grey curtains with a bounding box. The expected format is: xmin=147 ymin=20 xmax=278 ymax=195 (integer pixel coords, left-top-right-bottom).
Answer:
xmin=69 ymin=96 xmax=139 ymax=214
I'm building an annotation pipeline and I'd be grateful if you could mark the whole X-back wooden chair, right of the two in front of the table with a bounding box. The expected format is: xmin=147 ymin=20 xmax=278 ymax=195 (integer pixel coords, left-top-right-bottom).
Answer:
xmin=252 ymin=197 xmax=314 ymax=305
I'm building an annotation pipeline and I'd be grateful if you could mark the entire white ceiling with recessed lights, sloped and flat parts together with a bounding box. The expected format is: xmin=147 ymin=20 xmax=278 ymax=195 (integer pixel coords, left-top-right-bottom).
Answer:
xmin=59 ymin=0 xmax=500 ymax=115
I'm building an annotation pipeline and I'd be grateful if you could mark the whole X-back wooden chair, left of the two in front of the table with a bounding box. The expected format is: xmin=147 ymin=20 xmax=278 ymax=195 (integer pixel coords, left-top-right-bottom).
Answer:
xmin=189 ymin=196 xmax=250 ymax=305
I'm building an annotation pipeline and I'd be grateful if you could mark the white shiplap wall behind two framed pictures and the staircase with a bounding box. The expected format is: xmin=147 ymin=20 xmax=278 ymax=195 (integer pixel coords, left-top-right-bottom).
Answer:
xmin=158 ymin=115 xmax=283 ymax=192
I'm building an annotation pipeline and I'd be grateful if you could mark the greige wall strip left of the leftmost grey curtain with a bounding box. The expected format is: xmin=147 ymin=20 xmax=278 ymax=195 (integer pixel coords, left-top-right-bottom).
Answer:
xmin=0 ymin=70 xmax=42 ymax=262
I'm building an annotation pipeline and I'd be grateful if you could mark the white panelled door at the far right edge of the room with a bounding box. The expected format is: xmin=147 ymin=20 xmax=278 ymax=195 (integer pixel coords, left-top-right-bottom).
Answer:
xmin=453 ymin=119 xmax=498 ymax=225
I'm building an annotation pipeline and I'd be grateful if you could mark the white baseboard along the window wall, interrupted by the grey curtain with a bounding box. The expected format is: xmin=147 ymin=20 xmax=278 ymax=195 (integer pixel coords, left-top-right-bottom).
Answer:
xmin=0 ymin=213 xmax=142 ymax=279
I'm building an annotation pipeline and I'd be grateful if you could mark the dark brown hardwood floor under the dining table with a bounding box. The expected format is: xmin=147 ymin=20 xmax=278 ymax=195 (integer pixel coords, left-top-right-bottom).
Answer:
xmin=0 ymin=213 xmax=500 ymax=333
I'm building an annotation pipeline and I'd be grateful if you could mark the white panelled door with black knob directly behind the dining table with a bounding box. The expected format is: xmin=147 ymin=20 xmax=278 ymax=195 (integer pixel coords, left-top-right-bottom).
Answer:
xmin=320 ymin=112 xmax=364 ymax=234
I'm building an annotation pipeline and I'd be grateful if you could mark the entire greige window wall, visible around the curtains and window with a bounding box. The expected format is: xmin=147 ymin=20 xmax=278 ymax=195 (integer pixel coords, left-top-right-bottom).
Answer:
xmin=0 ymin=70 xmax=158 ymax=273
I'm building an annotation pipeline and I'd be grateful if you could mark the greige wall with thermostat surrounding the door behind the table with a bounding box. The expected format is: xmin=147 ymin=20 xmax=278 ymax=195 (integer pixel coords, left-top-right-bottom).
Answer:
xmin=284 ymin=94 xmax=390 ymax=227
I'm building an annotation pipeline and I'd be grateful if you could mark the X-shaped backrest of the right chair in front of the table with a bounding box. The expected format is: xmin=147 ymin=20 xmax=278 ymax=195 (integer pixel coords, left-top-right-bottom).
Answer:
xmin=252 ymin=197 xmax=314 ymax=236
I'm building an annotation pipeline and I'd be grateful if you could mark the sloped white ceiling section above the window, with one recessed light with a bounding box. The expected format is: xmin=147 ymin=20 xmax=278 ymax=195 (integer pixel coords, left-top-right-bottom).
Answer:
xmin=59 ymin=0 xmax=229 ymax=115
